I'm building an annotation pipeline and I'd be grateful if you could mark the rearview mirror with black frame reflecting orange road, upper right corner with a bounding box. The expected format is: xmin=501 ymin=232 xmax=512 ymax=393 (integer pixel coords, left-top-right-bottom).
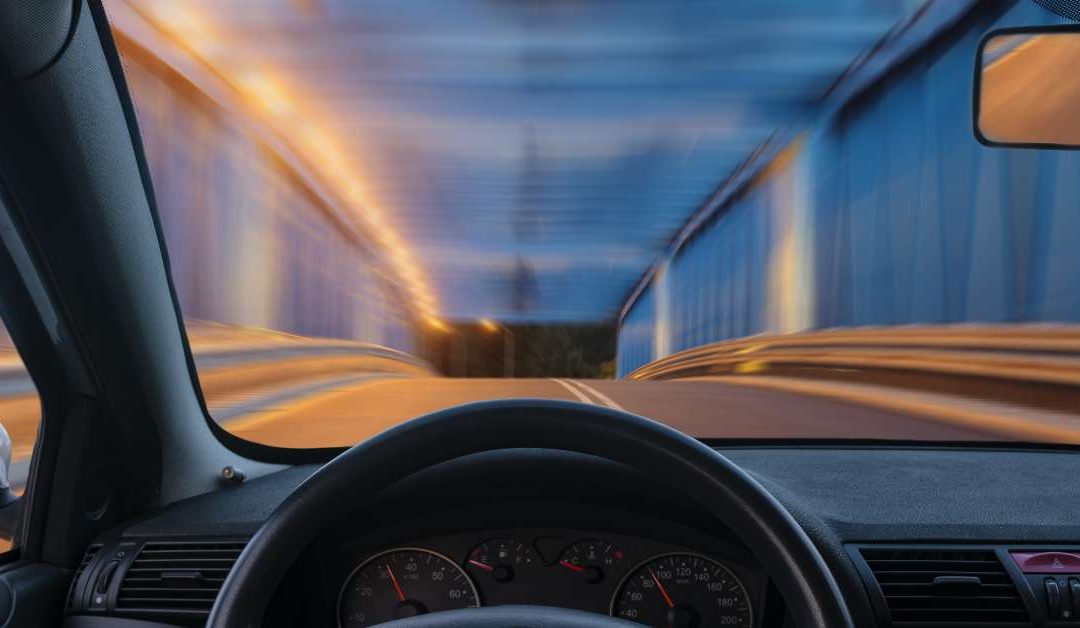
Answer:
xmin=974 ymin=25 xmax=1080 ymax=148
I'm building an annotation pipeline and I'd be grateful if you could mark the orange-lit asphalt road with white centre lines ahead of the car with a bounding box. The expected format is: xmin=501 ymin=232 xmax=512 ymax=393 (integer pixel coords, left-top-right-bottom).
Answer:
xmin=224 ymin=377 xmax=1002 ymax=446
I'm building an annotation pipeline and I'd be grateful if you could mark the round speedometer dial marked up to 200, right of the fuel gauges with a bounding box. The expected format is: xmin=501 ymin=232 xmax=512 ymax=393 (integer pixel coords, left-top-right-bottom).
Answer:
xmin=611 ymin=553 xmax=754 ymax=628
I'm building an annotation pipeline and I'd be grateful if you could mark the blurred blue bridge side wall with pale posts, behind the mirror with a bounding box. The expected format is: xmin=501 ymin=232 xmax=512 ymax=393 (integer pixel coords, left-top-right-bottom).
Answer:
xmin=618 ymin=2 xmax=1080 ymax=376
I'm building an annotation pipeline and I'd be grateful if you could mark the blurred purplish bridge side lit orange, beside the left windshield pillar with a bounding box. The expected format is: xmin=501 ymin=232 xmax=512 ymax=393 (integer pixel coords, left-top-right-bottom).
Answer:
xmin=107 ymin=1 xmax=424 ymax=352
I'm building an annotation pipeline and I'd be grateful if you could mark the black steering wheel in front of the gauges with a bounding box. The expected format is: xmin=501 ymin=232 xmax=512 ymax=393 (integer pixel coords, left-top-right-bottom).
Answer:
xmin=206 ymin=399 xmax=854 ymax=628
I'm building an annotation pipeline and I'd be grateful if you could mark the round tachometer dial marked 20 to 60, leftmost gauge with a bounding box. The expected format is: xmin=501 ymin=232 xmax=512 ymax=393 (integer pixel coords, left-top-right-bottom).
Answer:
xmin=338 ymin=547 xmax=480 ymax=628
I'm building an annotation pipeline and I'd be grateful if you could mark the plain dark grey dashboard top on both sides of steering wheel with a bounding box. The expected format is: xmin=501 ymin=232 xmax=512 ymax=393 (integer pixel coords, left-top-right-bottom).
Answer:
xmin=123 ymin=446 xmax=1080 ymax=542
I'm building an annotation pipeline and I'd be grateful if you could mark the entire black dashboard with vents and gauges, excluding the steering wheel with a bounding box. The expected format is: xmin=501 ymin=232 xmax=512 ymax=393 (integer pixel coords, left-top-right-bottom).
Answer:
xmin=66 ymin=446 xmax=1080 ymax=628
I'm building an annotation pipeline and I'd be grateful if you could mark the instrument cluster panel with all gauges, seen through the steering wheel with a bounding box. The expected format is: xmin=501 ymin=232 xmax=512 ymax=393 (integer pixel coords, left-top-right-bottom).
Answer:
xmin=337 ymin=527 xmax=765 ymax=628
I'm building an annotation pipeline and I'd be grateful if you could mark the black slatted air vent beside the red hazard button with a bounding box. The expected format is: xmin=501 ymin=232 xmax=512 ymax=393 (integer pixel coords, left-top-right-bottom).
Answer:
xmin=860 ymin=547 xmax=1028 ymax=627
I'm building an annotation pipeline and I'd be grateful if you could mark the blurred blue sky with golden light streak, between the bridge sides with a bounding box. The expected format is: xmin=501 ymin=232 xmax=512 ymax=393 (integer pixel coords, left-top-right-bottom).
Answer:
xmin=109 ymin=0 xmax=919 ymax=323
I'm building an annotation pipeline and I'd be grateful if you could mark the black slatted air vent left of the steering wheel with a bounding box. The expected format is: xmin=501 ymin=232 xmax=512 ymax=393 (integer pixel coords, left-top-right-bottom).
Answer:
xmin=116 ymin=542 xmax=244 ymax=618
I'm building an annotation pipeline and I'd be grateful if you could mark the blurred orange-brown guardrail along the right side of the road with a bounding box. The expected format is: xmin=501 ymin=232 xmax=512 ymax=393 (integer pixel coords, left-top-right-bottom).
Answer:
xmin=626 ymin=324 xmax=1080 ymax=413
